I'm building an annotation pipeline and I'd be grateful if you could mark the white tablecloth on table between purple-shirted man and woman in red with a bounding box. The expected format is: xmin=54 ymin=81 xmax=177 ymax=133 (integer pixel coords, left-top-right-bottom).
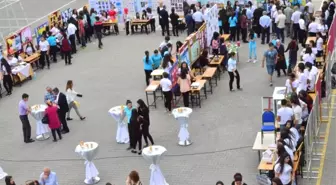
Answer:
xmin=31 ymin=104 xmax=50 ymax=136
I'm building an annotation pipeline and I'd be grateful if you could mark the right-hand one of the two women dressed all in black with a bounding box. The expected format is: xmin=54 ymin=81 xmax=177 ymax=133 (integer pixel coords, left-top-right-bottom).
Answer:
xmin=137 ymin=99 xmax=154 ymax=148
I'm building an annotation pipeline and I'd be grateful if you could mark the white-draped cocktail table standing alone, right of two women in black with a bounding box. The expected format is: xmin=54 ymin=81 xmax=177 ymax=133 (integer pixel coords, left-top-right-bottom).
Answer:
xmin=172 ymin=107 xmax=192 ymax=146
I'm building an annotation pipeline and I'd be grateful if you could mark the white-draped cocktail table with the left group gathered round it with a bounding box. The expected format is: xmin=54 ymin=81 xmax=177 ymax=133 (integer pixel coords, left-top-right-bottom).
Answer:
xmin=31 ymin=104 xmax=50 ymax=141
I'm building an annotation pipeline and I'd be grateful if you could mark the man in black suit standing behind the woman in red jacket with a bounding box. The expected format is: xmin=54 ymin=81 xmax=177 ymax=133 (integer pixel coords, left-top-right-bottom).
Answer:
xmin=53 ymin=87 xmax=70 ymax=134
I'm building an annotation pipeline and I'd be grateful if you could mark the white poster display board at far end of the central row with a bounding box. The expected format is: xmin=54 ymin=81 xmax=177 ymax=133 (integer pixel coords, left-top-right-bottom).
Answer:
xmin=205 ymin=4 xmax=219 ymax=47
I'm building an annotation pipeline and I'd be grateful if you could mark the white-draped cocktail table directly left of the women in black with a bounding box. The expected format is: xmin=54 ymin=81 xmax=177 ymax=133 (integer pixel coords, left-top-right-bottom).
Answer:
xmin=108 ymin=105 xmax=129 ymax=144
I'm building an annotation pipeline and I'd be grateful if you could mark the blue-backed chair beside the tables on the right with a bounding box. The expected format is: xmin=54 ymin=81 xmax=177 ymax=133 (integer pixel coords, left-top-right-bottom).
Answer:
xmin=261 ymin=111 xmax=276 ymax=144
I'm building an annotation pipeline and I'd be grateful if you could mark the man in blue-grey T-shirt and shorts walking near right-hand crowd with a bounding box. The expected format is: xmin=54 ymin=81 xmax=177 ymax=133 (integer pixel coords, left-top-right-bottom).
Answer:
xmin=261 ymin=43 xmax=278 ymax=86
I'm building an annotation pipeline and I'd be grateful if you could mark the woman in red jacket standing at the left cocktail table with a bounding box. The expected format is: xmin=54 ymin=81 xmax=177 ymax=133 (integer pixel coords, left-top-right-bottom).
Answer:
xmin=44 ymin=100 xmax=62 ymax=142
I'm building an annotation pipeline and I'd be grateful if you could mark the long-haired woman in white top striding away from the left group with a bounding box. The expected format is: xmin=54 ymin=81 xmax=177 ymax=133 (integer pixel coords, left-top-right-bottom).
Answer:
xmin=65 ymin=80 xmax=86 ymax=121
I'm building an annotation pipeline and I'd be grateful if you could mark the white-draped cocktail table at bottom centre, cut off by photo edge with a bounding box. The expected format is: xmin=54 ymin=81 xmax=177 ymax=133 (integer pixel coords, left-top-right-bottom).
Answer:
xmin=142 ymin=145 xmax=169 ymax=185
